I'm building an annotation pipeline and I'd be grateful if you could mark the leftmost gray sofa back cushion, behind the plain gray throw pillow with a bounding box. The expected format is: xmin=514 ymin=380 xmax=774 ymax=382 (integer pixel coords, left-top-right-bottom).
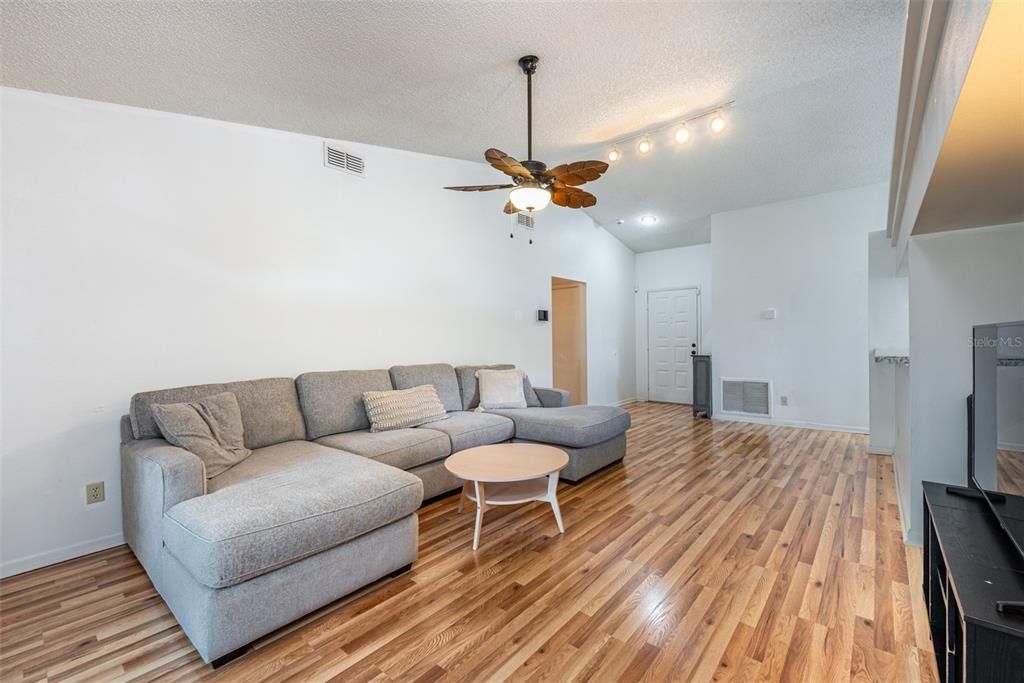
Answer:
xmin=129 ymin=377 xmax=306 ymax=449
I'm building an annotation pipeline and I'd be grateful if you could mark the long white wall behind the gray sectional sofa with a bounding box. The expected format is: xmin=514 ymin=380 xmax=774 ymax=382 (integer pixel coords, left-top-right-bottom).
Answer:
xmin=0 ymin=89 xmax=636 ymax=574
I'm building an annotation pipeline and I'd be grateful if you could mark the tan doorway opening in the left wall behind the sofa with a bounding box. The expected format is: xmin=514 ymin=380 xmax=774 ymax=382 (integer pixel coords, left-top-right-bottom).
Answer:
xmin=551 ymin=278 xmax=587 ymax=405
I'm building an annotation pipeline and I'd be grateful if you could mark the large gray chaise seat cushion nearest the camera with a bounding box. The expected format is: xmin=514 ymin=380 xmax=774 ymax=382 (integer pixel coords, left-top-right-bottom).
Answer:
xmin=163 ymin=441 xmax=423 ymax=588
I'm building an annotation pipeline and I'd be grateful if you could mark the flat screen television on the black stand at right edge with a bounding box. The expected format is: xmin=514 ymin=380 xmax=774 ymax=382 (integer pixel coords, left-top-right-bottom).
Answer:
xmin=968 ymin=322 xmax=1024 ymax=560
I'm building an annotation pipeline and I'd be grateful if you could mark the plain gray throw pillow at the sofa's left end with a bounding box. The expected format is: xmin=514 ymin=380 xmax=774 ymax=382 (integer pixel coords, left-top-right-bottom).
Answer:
xmin=152 ymin=391 xmax=252 ymax=479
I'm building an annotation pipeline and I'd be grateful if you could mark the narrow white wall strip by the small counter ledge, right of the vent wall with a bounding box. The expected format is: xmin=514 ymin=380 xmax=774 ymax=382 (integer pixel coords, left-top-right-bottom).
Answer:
xmin=867 ymin=230 xmax=910 ymax=455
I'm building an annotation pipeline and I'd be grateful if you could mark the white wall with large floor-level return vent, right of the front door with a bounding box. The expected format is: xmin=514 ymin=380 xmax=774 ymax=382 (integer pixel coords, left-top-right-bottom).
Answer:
xmin=711 ymin=183 xmax=888 ymax=431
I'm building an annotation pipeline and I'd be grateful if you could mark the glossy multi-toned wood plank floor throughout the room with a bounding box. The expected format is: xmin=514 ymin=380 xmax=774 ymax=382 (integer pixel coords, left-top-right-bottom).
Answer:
xmin=0 ymin=403 xmax=937 ymax=682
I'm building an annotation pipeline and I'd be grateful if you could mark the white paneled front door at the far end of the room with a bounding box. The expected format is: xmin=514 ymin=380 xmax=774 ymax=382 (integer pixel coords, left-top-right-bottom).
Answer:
xmin=647 ymin=288 xmax=698 ymax=403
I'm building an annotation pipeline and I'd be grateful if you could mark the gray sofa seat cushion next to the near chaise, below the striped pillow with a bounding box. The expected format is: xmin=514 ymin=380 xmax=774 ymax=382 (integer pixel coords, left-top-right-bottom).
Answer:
xmin=316 ymin=428 xmax=452 ymax=470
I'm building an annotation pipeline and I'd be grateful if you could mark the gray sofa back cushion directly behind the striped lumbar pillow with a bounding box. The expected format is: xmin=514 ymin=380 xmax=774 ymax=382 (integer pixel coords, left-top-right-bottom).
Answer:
xmin=295 ymin=370 xmax=394 ymax=439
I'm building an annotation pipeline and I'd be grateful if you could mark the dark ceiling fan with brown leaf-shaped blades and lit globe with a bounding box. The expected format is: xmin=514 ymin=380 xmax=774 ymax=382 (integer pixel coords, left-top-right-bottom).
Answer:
xmin=444 ymin=54 xmax=608 ymax=214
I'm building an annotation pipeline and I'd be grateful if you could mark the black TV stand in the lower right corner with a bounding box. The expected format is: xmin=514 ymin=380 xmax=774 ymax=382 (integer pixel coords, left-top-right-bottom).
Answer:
xmin=923 ymin=481 xmax=1024 ymax=683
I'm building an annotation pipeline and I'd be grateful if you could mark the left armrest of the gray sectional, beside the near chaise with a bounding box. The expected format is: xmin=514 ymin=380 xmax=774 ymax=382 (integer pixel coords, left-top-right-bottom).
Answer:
xmin=121 ymin=438 xmax=206 ymax=583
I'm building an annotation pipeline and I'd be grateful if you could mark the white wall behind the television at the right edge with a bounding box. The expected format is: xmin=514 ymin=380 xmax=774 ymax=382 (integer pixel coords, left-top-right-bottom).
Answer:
xmin=902 ymin=223 xmax=1024 ymax=544
